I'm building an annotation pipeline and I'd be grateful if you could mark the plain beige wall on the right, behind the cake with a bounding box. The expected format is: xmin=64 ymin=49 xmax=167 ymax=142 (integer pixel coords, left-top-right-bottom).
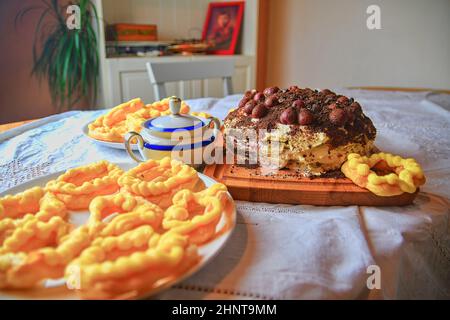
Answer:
xmin=266 ymin=0 xmax=450 ymax=89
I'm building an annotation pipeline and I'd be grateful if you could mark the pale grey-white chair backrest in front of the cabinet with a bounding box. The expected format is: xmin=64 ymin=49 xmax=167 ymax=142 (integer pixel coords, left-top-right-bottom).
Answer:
xmin=146 ymin=58 xmax=234 ymax=100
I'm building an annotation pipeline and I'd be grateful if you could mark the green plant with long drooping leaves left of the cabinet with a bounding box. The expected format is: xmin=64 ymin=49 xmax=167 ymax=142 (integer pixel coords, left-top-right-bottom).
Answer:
xmin=16 ymin=0 xmax=99 ymax=111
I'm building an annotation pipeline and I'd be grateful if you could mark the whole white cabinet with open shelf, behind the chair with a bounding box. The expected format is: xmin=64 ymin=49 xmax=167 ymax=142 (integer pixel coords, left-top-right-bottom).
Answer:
xmin=93 ymin=0 xmax=259 ymax=108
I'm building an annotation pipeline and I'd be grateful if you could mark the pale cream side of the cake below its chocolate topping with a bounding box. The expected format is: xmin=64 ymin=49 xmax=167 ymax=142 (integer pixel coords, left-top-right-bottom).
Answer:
xmin=225 ymin=124 xmax=374 ymax=176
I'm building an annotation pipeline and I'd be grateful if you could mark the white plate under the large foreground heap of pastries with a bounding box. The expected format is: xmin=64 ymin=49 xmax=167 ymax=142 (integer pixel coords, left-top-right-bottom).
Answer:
xmin=0 ymin=163 xmax=236 ymax=300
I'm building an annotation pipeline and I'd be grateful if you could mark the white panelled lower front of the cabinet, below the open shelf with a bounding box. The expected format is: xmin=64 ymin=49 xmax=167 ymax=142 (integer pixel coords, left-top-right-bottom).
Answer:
xmin=103 ymin=55 xmax=255 ymax=108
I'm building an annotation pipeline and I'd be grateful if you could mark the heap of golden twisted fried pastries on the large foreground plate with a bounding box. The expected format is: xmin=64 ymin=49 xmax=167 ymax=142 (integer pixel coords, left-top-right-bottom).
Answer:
xmin=0 ymin=158 xmax=232 ymax=299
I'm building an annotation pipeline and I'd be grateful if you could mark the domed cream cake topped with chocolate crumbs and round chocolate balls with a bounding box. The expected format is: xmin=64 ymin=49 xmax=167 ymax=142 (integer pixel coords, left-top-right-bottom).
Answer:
xmin=224 ymin=86 xmax=376 ymax=176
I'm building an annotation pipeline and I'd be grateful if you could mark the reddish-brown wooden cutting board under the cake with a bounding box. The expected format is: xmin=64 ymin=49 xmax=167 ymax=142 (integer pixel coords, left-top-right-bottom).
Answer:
xmin=203 ymin=164 xmax=417 ymax=206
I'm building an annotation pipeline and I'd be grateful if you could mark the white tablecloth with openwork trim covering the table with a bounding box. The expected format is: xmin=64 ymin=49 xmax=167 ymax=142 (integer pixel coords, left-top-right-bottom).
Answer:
xmin=0 ymin=90 xmax=450 ymax=299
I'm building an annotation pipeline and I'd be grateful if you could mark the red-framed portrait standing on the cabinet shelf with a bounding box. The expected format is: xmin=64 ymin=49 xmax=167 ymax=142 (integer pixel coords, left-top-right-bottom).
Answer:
xmin=203 ymin=1 xmax=244 ymax=55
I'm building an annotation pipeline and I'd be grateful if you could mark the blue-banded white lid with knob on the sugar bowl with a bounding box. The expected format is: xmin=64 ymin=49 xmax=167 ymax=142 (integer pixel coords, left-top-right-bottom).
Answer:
xmin=143 ymin=97 xmax=207 ymax=134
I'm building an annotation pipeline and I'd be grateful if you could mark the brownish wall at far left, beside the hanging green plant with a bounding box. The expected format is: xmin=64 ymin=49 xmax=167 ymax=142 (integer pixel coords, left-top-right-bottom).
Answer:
xmin=0 ymin=0 xmax=53 ymax=124
